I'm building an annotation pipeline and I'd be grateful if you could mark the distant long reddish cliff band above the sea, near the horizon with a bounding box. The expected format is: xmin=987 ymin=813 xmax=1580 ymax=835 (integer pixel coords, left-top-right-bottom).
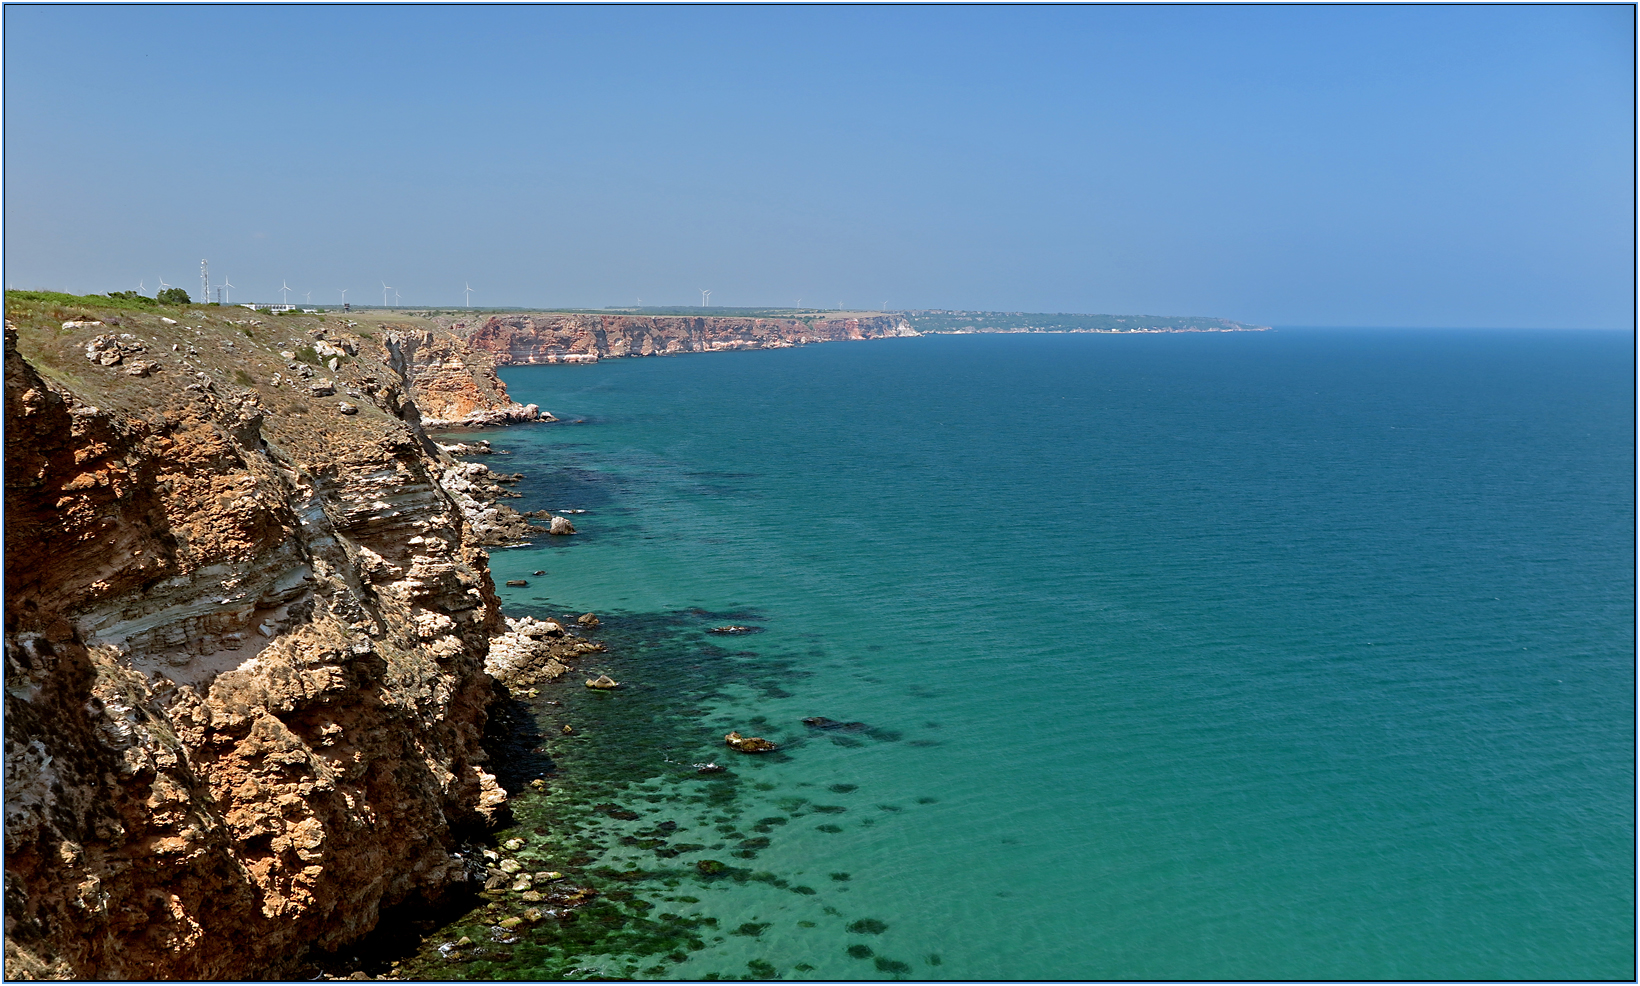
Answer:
xmin=449 ymin=313 xmax=917 ymax=366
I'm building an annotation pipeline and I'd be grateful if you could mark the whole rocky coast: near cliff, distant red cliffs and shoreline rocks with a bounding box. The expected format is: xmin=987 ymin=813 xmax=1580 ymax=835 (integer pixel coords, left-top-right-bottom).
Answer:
xmin=5 ymin=292 xmax=957 ymax=979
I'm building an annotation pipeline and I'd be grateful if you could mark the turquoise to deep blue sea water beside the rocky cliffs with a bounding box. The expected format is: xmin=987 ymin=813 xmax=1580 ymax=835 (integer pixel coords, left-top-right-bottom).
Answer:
xmin=432 ymin=330 xmax=1635 ymax=979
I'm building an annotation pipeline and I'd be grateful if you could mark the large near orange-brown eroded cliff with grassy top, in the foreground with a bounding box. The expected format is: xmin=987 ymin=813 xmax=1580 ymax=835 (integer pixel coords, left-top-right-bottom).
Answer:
xmin=5 ymin=305 xmax=551 ymax=979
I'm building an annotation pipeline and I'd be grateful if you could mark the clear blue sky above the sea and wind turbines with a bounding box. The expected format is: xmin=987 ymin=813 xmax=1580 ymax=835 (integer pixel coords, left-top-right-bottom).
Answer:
xmin=3 ymin=3 xmax=1635 ymax=328
